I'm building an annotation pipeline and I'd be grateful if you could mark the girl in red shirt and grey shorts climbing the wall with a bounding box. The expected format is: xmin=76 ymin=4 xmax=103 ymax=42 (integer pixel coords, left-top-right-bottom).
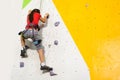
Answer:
xmin=19 ymin=9 xmax=52 ymax=71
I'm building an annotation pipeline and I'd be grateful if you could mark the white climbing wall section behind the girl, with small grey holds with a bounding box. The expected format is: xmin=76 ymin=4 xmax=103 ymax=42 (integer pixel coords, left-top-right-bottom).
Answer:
xmin=11 ymin=0 xmax=90 ymax=80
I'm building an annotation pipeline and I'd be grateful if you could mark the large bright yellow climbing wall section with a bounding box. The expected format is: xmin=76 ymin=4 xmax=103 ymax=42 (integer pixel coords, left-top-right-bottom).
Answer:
xmin=53 ymin=0 xmax=120 ymax=80
